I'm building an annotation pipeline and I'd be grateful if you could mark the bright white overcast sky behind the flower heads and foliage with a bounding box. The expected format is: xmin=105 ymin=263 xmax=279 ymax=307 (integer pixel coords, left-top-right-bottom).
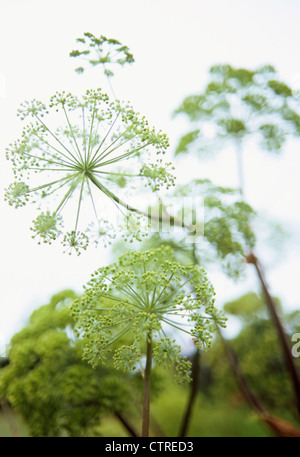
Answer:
xmin=0 ymin=0 xmax=300 ymax=352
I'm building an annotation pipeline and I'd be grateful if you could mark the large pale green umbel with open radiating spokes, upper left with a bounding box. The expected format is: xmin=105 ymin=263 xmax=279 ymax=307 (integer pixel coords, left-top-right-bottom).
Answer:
xmin=5 ymin=89 xmax=174 ymax=254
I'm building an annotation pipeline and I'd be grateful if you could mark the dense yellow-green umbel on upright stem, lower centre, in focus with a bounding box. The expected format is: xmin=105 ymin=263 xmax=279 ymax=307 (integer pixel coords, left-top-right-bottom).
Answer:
xmin=73 ymin=246 xmax=225 ymax=381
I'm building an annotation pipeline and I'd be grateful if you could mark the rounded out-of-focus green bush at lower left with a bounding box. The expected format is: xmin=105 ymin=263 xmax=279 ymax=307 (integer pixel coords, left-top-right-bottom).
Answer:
xmin=0 ymin=290 xmax=141 ymax=436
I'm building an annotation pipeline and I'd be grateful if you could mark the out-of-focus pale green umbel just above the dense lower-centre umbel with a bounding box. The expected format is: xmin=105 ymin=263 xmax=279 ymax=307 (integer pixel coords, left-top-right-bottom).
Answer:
xmin=113 ymin=179 xmax=256 ymax=278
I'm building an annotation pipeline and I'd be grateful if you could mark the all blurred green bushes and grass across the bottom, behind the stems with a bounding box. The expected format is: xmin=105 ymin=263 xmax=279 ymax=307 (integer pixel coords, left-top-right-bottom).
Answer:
xmin=0 ymin=291 xmax=300 ymax=437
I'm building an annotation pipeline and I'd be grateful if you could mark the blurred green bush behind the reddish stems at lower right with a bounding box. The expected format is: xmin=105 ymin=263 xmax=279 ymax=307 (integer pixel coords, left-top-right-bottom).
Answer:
xmin=203 ymin=292 xmax=300 ymax=425
